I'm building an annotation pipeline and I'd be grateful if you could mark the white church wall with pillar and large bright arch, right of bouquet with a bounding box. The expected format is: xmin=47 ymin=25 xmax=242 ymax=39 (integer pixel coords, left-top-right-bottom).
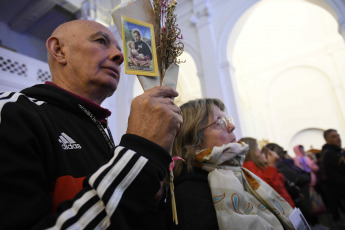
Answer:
xmin=173 ymin=0 xmax=345 ymax=155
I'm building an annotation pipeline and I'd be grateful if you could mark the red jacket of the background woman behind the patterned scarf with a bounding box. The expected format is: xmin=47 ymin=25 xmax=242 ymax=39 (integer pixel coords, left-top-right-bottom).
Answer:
xmin=243 ymin=161 xmax=295 ymax=208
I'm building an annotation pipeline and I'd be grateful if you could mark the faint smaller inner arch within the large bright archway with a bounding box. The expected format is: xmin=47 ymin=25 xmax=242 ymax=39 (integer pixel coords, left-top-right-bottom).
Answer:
xmin=259 ymin=65 xmax=345 ymax=149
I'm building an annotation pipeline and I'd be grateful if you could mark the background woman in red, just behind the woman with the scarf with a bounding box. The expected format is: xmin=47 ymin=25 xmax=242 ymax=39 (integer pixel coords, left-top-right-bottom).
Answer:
xmin=241 ymin=137 xmax=295 ymax=208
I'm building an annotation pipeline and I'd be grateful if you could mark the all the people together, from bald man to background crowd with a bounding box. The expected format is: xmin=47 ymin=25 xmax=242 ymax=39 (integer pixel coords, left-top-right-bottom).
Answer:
xmin=0 ymin=20 xmax=345 ymax=230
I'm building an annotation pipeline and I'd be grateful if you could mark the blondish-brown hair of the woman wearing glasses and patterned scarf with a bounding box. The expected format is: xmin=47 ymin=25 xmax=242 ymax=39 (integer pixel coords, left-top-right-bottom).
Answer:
xmin=173 ymin=98 xmax=225 ymax=176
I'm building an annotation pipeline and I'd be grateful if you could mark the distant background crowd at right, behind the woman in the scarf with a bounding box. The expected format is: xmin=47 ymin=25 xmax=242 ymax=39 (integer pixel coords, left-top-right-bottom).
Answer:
xmin=236 ymin=129 xmax=345 ymax=229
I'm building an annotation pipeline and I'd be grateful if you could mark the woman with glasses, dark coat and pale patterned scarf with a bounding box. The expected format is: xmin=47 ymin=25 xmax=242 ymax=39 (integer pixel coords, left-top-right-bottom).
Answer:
xmin=169 ymin=99 xmax=293 ymax=230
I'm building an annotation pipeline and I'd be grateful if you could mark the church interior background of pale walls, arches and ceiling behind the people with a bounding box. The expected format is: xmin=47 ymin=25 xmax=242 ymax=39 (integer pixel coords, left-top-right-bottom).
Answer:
xmin=0 ymin=0 xmax=345 ymax=156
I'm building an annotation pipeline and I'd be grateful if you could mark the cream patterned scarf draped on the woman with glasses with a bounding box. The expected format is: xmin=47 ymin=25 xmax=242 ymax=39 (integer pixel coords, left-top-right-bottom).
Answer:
xmin=196 ymin=143 xmax=294 ymax=230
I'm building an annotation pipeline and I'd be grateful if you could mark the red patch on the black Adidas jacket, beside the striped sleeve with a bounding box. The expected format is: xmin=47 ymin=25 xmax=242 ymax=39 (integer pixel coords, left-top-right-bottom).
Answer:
xmin=52 ymin=175 xmax=85 ymax=213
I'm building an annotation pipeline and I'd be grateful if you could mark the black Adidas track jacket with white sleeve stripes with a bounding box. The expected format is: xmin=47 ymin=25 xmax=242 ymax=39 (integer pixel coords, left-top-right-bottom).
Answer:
xmin=0 ymin=84 xmax=171 ymax=229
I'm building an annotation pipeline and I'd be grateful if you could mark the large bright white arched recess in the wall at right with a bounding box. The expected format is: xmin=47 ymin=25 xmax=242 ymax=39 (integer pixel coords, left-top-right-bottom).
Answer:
xmin=228 ymin=0 xmax=345 ymax=155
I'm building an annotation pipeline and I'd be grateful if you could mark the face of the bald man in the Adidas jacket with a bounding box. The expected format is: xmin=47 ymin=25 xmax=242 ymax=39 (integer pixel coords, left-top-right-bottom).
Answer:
xmin=63 ymin=21 xmax=123 ymax=99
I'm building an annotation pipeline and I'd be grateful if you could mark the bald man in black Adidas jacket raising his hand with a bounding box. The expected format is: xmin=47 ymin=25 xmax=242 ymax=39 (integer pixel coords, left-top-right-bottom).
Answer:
xmin=0 ymin=20 xmax=182 ymax=229
